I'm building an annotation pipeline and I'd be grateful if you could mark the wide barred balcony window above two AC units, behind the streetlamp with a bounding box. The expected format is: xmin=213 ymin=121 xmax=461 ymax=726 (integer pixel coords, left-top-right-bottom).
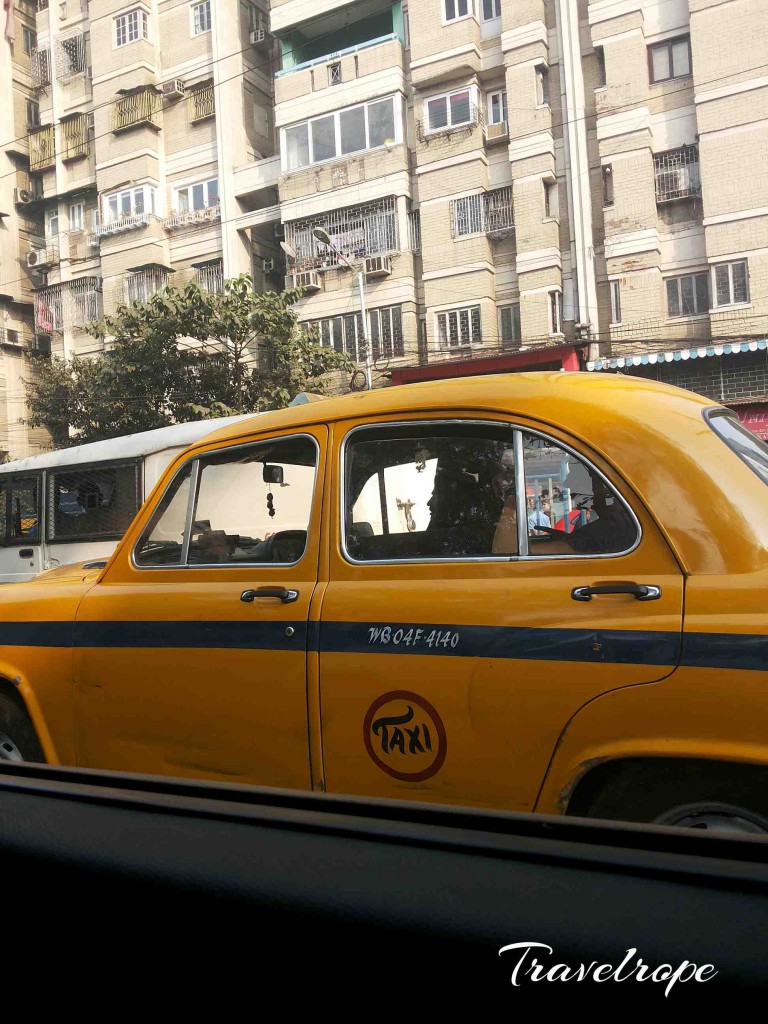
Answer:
xmin=285 ymin=196 xmax=399 ymax=273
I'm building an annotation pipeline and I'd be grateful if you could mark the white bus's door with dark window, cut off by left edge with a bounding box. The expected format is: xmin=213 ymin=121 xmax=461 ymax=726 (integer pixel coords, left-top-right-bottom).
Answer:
xmin=0 ymin=473 xmax=43 ymax=583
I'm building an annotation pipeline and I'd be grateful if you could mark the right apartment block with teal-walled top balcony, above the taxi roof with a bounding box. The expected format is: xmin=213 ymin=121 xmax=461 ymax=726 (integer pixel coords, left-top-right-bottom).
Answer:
xmin=271 ymin=0 xmax=768 ymax=411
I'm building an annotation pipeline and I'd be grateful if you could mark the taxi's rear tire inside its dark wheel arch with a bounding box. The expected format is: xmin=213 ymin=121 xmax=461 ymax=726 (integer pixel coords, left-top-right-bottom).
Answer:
xmin=570 ymin=759 xmax=768 ymax=834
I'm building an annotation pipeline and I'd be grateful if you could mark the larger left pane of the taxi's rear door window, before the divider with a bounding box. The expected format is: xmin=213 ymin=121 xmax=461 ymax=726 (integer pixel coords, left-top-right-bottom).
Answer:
xmin=344 ymin=424 xmax=517 ymax=561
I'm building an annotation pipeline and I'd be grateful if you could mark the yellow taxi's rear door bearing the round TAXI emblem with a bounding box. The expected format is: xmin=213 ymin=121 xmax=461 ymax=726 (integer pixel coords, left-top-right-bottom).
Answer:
xmin=318 ymin=414 xmax=683 ymax=810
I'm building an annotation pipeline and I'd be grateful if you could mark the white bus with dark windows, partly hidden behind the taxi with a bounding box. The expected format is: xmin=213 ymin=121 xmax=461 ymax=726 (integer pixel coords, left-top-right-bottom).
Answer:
xmin=0 ymin=416 xmax=248 ymax=583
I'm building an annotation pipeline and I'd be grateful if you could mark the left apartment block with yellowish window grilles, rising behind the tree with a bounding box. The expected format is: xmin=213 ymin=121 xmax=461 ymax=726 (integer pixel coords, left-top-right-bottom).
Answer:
xmin=0 ymin=0 xmax=283 ymax=456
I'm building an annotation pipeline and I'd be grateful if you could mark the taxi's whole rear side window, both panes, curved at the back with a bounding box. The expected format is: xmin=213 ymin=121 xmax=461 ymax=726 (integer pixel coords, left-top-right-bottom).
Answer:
xmin=344 ymin=423 xmax=639 ymax=561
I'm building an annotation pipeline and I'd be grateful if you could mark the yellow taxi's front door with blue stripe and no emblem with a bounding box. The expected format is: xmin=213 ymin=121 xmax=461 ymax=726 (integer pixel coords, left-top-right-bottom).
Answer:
xmin=76 ymin=427 xmax=328 ymax=788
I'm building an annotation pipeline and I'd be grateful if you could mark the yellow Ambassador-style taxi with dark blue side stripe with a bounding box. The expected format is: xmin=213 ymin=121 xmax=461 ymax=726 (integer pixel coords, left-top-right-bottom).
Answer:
xmin=0 ymin=372 xmax=768 ymax=833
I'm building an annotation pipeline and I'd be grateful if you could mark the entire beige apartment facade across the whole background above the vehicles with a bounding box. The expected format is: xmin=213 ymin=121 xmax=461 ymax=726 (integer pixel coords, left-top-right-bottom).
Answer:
xmin=0 ymin=0 xmax=768 ymax=454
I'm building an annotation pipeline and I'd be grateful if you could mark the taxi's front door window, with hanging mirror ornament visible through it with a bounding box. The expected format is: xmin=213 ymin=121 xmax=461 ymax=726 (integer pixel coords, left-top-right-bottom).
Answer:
xmin=135 ymin=435 xmax=317 ymax=566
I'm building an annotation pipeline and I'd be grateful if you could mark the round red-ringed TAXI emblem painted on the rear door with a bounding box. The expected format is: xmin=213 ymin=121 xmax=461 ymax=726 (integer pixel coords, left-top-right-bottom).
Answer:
xmin=362 ymin=690 xmax=447 ymax=782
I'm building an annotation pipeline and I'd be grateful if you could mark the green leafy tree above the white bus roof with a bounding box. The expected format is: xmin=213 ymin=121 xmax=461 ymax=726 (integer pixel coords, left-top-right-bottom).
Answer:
xmin=27 ymin=274 xmax=353 ymax=447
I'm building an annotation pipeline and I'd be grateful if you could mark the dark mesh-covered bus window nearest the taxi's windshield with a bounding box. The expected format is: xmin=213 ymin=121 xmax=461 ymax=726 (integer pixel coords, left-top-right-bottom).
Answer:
xmin=47 ymin=462 xmax=141 ymax=544
